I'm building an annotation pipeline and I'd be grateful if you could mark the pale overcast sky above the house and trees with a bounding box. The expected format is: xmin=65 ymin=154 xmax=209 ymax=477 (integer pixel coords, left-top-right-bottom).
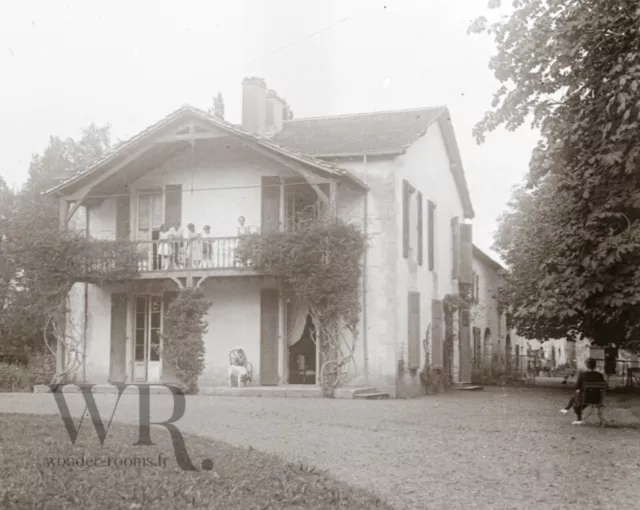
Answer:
xmin=0 ymin=0 xmax=536 ymax=258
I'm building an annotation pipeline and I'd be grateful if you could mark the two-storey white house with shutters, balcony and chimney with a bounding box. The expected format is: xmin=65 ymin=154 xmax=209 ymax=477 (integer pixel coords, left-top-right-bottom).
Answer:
xmin=48 ymin=78 xmax=474 ymax=396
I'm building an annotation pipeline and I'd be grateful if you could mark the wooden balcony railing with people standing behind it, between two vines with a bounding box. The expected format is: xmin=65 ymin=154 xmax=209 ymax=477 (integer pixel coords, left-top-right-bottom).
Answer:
xmin=135 ymin=237 xmax=249 ymax=273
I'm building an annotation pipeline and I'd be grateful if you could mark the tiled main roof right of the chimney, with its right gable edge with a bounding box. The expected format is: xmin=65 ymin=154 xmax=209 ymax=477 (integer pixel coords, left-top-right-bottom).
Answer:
xmin=271 ymin=106 xmax=475 ymax=219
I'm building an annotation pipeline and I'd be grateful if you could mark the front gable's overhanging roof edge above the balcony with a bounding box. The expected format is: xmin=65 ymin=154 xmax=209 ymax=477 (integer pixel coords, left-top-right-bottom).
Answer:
xmin=44 ymin=105 xmax=367 ymax=195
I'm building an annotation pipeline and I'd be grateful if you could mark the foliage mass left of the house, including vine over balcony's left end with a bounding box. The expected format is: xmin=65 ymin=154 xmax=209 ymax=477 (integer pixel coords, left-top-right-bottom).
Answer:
xmin=0 ymin=125 xmax=139 ymax=375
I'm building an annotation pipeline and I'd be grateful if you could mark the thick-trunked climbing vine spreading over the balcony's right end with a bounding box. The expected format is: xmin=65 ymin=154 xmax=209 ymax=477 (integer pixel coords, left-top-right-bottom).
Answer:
xmin=236 ymin=218 xmax=366 ymax=397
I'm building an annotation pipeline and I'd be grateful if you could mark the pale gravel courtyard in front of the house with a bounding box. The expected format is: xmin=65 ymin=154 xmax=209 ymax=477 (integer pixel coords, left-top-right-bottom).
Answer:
xmin=0 ymin=388 xmax=640 ymax=509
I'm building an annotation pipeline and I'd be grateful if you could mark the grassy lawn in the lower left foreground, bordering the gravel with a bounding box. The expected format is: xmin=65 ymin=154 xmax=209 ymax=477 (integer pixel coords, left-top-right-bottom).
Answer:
xmin=0 ymin=414 xmax=391 ymax=510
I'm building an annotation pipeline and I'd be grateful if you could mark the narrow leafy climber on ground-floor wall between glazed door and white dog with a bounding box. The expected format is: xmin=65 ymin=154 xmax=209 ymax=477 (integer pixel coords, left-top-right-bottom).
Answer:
xmin=162 ymin=289 xmax=211 ymax=393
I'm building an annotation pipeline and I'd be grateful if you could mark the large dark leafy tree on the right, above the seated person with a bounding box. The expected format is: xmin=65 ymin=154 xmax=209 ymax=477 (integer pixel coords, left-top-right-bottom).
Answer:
xmin=470 ymin=0 xmax=640 ymax=347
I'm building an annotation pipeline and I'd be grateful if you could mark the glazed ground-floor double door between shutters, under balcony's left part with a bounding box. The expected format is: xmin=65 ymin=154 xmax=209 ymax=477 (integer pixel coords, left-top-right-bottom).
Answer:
xmin=134 ymin=295 xmax=163 ymax=383
